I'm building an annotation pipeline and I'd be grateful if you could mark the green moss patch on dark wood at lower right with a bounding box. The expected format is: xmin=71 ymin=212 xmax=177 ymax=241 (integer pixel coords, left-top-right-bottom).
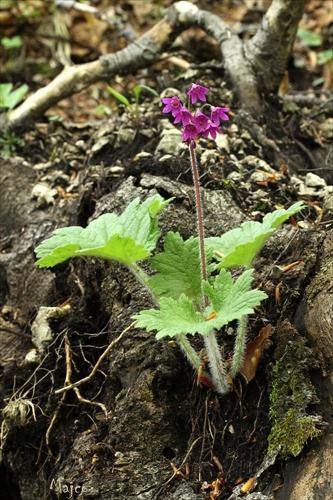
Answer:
xmin=268 ymin=340 xmax=322 ymax=459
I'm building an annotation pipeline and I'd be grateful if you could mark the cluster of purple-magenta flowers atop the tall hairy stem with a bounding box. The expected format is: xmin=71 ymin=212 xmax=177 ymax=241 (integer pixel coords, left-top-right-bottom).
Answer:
xmin=162 ymin=83 xmax=229 ymax=148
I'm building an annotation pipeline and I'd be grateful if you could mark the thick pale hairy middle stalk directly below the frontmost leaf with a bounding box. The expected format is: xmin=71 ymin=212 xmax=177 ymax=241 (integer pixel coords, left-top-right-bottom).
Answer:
xmin=204 ymin=330 xmax=230 ymax=395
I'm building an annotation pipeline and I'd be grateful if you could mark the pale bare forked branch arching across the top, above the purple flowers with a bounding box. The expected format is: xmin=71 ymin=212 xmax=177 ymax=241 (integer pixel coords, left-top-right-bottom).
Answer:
xmin=8 ymin=0 xmax=306 ymax=129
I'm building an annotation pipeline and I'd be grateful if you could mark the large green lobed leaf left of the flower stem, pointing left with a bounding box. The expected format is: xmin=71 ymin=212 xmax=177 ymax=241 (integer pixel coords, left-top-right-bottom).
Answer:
xmin=35 ymin=195 xmax=171 ymax=267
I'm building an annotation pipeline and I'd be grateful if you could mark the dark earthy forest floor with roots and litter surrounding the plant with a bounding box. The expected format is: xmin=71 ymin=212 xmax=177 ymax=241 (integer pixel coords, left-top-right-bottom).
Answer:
xmin=0 ymin=0 xmax=333 ymax=500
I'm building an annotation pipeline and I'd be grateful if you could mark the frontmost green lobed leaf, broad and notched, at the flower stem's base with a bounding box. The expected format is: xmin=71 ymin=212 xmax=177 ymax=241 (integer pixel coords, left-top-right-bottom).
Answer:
xmin=133 ymin=269 xmax=267 ymax=339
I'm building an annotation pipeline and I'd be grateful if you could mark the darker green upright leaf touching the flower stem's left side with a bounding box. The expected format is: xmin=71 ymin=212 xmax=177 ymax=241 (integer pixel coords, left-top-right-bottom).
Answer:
xmin=149 ymin=232 xmax=202 ymax=304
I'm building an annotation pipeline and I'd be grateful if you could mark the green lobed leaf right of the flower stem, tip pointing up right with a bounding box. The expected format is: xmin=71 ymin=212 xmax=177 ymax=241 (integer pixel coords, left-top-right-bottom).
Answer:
xmin=205 ymin=201 xmax=304 ymax=269
